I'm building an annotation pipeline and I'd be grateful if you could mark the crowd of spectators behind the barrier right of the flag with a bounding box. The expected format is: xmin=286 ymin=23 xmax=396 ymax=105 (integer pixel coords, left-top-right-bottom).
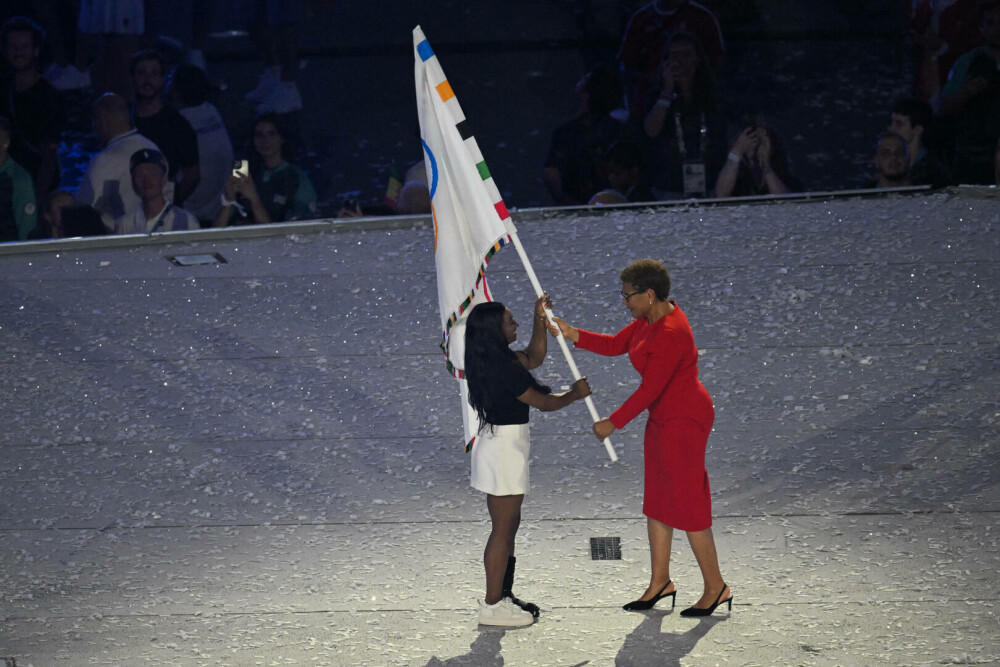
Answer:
xmin=542 ymin=0 xmax=1000 ymax=205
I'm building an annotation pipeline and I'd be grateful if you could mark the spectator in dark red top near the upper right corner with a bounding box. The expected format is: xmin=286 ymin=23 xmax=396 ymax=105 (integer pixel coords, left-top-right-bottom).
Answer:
xmin=903 ymin=0 xmax=983 ymax=101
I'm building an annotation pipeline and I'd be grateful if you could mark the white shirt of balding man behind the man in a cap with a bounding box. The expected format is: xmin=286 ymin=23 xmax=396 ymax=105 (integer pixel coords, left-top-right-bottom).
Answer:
xmin=76 ymin=130 xmax=164 ymax=229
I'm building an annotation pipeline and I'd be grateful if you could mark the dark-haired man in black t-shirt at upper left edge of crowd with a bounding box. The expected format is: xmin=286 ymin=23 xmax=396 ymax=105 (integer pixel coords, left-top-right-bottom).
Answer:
xmin=0 ymin=16 xmax=63 ymax=199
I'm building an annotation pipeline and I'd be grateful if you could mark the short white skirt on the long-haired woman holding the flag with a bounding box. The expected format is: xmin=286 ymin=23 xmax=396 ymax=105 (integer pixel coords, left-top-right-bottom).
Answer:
xmin=472 ymin=424 xmax=531 ymax=496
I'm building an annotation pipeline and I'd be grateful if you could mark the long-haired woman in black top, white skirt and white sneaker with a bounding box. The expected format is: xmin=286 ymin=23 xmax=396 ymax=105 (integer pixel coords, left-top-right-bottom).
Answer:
xmin=465 ymin=295 xmax=590 ymax=626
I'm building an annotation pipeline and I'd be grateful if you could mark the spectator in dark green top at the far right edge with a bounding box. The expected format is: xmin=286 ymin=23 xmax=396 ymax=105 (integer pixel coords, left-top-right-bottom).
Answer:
xmin=939 ymin=0 xmax=1000 ymax=185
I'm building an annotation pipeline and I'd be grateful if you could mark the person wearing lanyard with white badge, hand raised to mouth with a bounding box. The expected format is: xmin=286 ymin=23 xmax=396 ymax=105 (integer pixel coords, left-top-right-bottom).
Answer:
xmin=643 ymin=32 xmax=726 ymax=199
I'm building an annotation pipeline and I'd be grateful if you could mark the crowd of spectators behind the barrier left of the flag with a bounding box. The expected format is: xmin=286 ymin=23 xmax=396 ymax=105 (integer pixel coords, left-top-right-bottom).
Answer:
xmin=0 ymin=0 xmax=316 ymax=242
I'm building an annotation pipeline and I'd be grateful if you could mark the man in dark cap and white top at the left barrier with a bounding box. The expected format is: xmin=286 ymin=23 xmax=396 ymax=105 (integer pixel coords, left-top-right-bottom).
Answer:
xmin=115 ymin=148 xmax=200 ymax=234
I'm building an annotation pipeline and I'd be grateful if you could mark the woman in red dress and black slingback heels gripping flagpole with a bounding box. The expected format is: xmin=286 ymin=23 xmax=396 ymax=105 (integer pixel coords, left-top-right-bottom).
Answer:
xmin=556 ymin=259 xmax=733 ymax=616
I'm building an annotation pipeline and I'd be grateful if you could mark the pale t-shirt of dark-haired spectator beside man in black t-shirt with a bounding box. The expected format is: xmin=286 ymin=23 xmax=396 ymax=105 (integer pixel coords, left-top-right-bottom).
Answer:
xmin=180 ymin=102 xmax=233 ymax=220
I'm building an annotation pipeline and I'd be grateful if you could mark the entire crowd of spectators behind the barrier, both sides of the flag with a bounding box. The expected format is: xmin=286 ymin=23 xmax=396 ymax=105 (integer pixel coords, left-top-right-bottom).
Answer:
xmin=0 ymin=0 xmax=1000 ymax=242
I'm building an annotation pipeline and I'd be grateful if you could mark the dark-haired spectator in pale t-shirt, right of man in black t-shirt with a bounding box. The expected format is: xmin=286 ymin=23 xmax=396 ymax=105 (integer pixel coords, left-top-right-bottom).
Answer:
xmin=167 ymin=65 xmax=233 ymax=227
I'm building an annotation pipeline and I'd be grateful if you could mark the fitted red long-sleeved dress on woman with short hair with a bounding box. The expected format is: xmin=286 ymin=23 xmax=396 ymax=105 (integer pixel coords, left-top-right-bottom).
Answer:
xmin=576 ymin=301 xmax=715 ymax=531
